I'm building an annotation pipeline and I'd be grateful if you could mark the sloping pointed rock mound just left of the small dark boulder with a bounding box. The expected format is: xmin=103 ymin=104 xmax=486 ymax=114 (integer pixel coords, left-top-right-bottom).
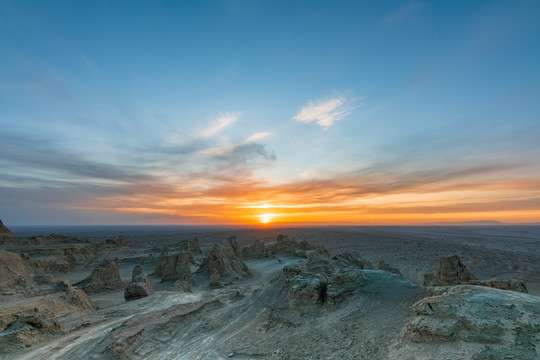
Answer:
xmin=75 ymin=258 xmax=124 ymax=294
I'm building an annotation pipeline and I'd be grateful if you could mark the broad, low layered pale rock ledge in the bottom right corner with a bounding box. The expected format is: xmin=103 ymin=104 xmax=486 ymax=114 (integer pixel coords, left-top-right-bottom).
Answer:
xmin=409 ymin=285 xmax=540 ymax=359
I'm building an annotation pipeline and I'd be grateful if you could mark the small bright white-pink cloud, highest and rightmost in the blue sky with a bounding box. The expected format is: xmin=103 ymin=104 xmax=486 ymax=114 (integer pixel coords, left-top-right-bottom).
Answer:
xmin=293 ymin=97 xmax=350 ymax=129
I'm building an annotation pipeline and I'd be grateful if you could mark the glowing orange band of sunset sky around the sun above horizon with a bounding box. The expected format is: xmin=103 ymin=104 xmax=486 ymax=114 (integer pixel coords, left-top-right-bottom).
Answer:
xmin=77 ymin=174 xmax=540 ymax=226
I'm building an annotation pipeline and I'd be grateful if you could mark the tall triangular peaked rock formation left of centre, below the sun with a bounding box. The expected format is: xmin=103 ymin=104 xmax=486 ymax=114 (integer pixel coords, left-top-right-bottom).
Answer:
xmin=196 ymin=236 xmax=250 ymax=279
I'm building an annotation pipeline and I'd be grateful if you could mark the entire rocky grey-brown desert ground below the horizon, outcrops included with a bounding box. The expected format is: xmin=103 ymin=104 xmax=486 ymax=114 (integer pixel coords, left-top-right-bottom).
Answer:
xmin=0 ymin=221 xmax=540 ymax=359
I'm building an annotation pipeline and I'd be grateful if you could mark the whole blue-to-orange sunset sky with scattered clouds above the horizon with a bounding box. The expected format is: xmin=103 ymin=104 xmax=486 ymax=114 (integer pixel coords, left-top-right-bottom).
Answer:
xmin=0 ymin=0 xmax=540 ymax=226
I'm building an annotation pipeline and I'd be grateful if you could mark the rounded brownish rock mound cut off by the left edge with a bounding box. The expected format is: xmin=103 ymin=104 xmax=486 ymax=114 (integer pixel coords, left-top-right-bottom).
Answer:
xmin=0 ymin=250 xmax=32 ymax=291
